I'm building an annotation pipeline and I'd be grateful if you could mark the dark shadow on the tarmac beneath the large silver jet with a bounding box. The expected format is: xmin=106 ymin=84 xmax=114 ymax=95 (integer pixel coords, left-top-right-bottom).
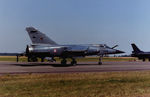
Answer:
xmin=13 ymin=63 xmax=101 ymax=67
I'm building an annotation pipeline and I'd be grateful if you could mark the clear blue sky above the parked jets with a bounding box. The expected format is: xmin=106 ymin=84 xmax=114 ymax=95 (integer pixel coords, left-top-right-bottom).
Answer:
xmin=0 ymin=0 xmax=150 ymax=54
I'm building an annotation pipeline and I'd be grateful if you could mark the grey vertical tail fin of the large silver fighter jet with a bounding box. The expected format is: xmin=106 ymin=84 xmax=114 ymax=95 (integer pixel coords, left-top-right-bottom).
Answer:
xmin=26 ymin=27 xmax=57 ymax=45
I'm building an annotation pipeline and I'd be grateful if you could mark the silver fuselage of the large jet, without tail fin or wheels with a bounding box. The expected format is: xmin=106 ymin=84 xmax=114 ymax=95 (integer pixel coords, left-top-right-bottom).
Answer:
xmin=28 ymin=45 xmax=121 ymax=57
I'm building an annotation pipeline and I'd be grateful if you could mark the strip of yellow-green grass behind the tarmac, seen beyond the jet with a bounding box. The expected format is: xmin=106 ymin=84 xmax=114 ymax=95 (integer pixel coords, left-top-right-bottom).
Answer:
xmin=0 ymin=56 xmax=136 ymax=62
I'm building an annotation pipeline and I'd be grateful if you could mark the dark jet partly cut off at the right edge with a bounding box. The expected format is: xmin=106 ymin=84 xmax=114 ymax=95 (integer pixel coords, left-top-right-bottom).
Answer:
xmin=131 ymin=44 xmax=150 ymax=61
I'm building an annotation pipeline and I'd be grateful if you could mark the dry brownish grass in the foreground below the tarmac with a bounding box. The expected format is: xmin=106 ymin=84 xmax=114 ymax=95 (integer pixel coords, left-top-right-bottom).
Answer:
xmin=0 ymin=71 xmax=150 ymax=97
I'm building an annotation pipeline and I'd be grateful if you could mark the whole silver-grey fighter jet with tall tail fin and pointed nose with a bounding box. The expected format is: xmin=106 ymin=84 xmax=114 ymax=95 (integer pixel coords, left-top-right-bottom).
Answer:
xmin=18 ymin=27 xmax=124 ymax=65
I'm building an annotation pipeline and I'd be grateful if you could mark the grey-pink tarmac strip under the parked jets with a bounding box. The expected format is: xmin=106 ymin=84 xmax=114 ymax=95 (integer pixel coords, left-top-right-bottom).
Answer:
xmin=0 ymin=62 xmax=150 ymax=75
